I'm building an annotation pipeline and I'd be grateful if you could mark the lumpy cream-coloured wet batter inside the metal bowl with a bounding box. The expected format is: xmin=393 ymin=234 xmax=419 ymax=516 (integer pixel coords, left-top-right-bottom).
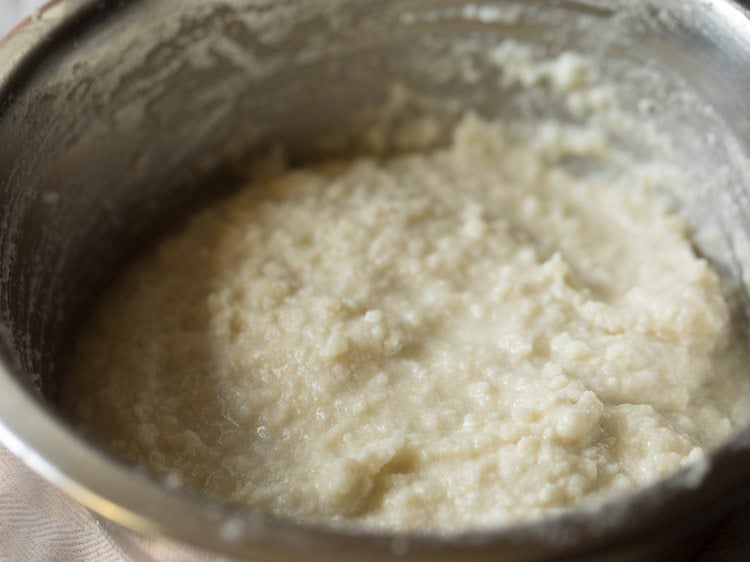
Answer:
xmin=64 ymin=114 xmax=750 ymax=531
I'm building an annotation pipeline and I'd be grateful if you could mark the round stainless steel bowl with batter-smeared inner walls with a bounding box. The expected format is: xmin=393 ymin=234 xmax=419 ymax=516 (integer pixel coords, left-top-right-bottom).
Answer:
xmin=0 ymin=0 xmax=750 ymax=560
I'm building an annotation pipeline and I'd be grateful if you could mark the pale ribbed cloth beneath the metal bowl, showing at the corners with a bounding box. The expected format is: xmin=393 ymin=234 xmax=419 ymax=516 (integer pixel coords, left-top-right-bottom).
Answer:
xmin=0 ymin=0 xmax=750 ymax=562
